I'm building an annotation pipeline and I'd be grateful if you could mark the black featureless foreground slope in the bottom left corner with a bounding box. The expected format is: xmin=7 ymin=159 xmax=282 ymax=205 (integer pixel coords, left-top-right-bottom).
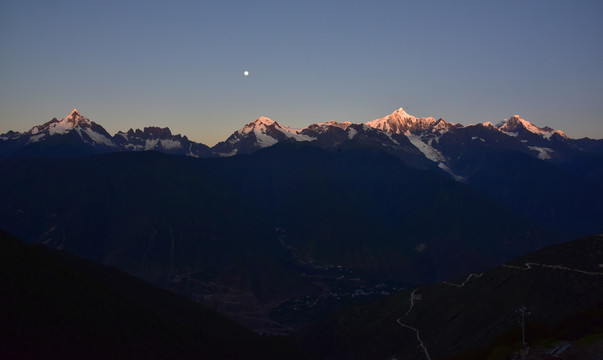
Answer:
xmin=0 ymin=231 xmax=300 ymax=359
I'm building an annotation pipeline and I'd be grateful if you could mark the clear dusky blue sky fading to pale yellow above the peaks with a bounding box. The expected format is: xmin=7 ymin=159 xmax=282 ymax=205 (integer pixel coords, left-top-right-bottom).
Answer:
xmin=0 ymin=0 xmax=603 ymax=146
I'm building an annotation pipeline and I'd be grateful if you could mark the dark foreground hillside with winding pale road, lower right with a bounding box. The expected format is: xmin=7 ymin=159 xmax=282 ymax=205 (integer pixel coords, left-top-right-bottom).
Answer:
xmin=297 ymin=235 xmax=603 ymax=360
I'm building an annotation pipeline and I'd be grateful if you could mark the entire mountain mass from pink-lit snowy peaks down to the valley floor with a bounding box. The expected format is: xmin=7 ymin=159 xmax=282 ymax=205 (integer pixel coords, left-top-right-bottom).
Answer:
xmin=0 ymin=109 xmax=603 ymax=334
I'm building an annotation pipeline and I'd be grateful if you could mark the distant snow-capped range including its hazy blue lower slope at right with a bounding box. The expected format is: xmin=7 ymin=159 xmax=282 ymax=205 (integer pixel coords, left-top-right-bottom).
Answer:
xmin=0 ymin=108 xmax=603 ymax=238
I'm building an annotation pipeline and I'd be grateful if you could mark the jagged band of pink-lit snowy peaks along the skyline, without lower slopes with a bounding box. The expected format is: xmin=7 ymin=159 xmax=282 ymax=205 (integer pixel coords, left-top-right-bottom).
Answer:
xmin=0 ymin=108 xmax=603 ymax=171
